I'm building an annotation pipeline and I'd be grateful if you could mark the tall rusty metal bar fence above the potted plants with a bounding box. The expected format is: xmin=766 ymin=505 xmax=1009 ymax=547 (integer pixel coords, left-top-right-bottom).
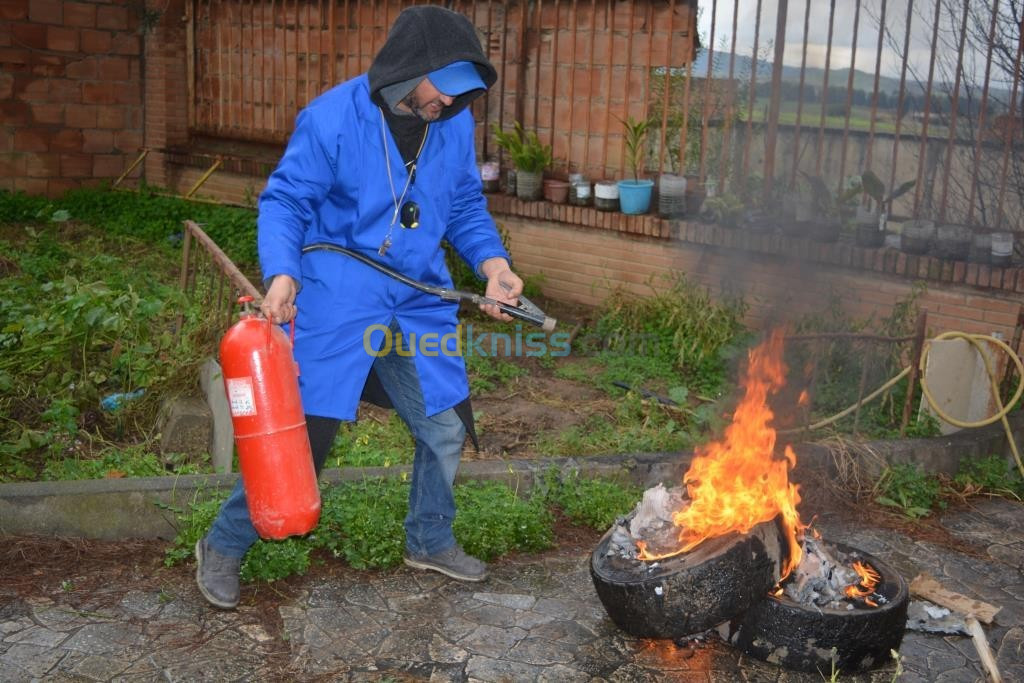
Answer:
xmin=186 ymin=0 xmax=1024 ymax=229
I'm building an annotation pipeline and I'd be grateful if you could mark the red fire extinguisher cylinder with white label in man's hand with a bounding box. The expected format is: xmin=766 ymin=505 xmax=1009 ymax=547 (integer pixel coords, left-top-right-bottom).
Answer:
xmin=220 ymin=296 xmax=321 ymax=539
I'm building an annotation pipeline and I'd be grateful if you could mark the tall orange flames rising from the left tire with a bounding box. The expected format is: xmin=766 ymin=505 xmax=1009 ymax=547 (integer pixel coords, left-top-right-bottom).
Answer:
xmin=638 ymin=331 xmax=805 ymax=579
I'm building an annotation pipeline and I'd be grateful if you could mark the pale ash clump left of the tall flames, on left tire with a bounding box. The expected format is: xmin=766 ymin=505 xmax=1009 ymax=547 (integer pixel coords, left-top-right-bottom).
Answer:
xmin=606 ymin=483 xmax=687 ymax=566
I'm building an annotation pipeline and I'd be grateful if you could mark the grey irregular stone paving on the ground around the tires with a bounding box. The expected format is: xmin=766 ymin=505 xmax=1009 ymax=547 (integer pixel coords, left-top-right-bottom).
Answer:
xmin=0 ymin=499 xmax=1024 ymax=683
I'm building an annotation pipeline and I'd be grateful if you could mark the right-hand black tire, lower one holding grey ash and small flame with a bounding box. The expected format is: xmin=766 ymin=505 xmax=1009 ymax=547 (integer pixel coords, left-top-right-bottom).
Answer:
xmin=729 ymin=544 xmax=908 ymax=676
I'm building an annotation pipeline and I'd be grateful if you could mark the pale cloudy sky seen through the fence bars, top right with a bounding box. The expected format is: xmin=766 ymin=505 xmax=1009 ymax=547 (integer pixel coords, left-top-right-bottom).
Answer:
xmin=697 ymin=0 xmax=1015 ymax=87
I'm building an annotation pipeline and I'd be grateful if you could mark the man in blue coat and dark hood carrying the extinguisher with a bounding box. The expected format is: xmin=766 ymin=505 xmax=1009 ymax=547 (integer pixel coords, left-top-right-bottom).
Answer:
xmin=196 ymin=5 xmax=522 ymax=608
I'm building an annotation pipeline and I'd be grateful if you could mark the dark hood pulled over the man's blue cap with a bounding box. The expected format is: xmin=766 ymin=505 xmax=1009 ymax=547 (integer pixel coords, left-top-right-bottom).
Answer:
xmin=368 ymin=5 xmax=498 ymax=119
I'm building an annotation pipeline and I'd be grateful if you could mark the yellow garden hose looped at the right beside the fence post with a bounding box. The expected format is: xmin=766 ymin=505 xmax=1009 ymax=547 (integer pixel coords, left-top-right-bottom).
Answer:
xmin=779 ymin=332 xmax=1024 ymax=477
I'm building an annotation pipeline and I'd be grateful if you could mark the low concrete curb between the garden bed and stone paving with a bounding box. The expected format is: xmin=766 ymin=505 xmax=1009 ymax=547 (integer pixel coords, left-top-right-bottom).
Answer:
xmin=0 ymin=413 xmax=1024 ymax=540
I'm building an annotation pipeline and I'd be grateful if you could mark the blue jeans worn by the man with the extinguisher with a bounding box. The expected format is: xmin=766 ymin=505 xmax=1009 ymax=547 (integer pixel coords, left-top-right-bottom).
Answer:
xmin=207 ymin=321 xmax=466 ymax=557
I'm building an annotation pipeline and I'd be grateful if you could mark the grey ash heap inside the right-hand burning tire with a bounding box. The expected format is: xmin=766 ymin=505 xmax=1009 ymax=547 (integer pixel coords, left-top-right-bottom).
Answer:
xmin=782 ymin=537 xmax=885 ymax=609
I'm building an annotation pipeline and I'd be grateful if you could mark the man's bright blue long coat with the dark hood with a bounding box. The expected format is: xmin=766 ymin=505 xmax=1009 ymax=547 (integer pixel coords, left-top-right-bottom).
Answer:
xmin=258 ymin=6 xmax=509 ymax=420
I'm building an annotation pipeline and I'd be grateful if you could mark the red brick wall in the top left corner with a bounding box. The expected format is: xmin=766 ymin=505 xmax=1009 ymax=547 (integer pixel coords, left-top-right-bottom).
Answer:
xmin=0 ymin=0 xmax=142 ymax=197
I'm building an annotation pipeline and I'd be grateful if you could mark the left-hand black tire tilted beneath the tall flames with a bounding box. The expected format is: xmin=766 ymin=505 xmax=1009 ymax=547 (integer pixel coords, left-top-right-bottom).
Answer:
xmin=590 ymin=522 xmax=783 ymax=638
